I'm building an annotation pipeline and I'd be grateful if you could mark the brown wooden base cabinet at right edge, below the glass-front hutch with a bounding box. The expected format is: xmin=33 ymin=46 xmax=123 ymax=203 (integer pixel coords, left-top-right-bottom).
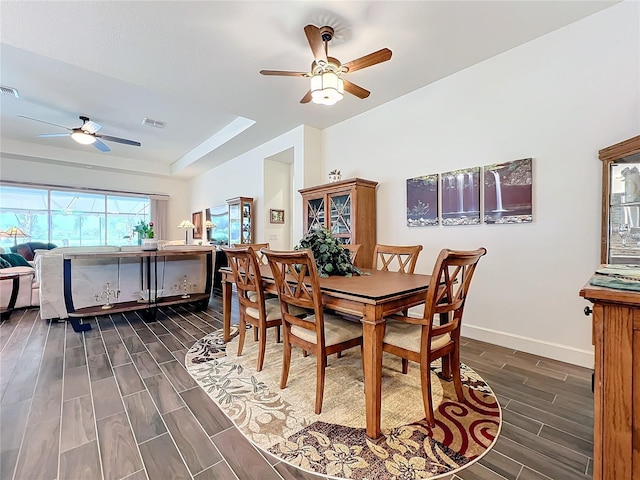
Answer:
xmin=580 ymin=284 xmax=640 ymax=480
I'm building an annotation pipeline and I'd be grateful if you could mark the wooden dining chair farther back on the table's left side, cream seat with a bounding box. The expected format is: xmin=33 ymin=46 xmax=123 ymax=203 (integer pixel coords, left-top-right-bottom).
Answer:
xmin=222 ymin=245 xmax=282 ymax=372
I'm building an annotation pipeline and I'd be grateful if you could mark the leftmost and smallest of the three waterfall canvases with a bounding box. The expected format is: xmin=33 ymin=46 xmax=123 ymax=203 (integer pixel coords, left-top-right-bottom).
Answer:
xmin=407 ymin=173 xmax=440 ymax=227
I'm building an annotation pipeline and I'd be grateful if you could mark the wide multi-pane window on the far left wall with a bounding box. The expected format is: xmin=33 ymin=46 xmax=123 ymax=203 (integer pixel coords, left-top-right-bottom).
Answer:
xmin=0 ymin=185 xmax=151 ymax=249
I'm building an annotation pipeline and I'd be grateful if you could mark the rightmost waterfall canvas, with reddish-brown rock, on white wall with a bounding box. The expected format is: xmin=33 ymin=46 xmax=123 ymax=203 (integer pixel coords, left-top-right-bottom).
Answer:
xmin=484 ymin=158 xmax=533 ymax=223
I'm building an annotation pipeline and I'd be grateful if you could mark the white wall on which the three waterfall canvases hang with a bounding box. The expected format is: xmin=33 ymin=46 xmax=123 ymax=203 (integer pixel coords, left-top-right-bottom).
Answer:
xmin=324 ymin=2 xmax=640 ymax=366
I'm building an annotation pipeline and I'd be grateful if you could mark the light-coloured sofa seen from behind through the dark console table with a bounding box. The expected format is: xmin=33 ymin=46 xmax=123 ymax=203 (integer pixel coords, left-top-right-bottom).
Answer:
xmin=34 ymin=244 xmax=215 ymax=319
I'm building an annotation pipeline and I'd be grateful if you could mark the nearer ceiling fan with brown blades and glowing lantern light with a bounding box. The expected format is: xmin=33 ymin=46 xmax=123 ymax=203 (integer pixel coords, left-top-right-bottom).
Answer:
xmin=260 ymin=25 xmax=391 ymax=105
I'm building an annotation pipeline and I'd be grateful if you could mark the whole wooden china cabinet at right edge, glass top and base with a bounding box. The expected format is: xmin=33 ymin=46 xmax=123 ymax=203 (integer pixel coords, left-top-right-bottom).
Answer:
xmin=580 ymin=136 xmax=640 ymax=480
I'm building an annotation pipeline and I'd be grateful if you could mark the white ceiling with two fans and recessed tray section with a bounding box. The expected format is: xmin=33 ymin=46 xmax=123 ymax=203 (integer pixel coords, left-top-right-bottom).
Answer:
xmin=0 ymin=0 xmax=617 ymax=178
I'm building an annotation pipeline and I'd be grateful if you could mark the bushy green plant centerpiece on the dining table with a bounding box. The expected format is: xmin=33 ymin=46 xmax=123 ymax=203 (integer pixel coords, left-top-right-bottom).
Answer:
xmin=295 ymin=228 xmax=362 ymax=277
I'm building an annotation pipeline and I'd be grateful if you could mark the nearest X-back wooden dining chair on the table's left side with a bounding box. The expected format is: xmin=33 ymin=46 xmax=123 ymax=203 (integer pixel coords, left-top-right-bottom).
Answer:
xmin=264 ymin=250 xmax=362 ymax=414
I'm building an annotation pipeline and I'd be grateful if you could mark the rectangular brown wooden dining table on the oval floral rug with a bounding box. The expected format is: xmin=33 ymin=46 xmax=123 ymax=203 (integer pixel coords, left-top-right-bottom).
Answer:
xmin=220 ymin=265 xmax=432 ymax=440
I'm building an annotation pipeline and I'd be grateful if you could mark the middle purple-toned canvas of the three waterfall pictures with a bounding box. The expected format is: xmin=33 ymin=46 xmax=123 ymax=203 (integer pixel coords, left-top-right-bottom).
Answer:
xmin=440 ymin=167 xmax=480 ymax=225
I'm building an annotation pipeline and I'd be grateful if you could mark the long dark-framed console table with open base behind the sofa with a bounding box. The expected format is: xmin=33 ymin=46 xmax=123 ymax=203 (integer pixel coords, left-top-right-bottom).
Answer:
xmin=63 ymin=248 xmax=214 ymax=332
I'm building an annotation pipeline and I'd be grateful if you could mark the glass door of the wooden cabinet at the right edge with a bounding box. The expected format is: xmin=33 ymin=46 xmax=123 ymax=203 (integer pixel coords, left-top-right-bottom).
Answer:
xmin=608 ymin=156 xmax=640 ymax=265
